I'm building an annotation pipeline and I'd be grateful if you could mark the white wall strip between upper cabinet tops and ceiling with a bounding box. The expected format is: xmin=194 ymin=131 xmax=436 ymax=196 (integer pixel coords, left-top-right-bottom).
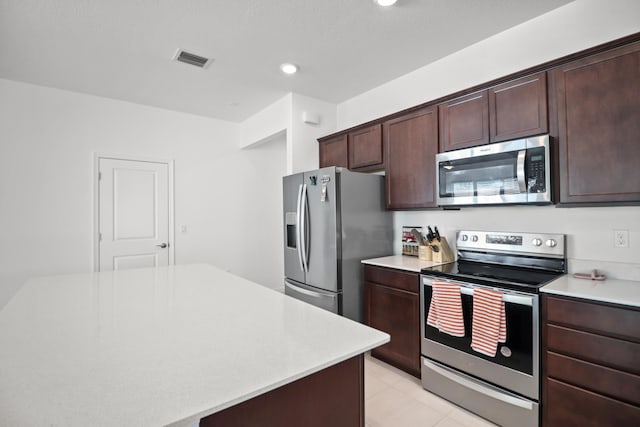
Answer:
xmin=337 ymin=0 xmax=640 ymax=129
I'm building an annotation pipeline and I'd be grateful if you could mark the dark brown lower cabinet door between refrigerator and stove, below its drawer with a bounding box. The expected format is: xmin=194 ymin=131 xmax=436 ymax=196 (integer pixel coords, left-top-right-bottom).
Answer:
xmin=365 ymin=282 xmax=420 ymax=376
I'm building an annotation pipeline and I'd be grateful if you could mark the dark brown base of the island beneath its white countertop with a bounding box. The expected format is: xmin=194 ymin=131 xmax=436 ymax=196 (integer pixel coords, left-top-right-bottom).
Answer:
xmin=200 ymin=355 xmax=364 ymax=427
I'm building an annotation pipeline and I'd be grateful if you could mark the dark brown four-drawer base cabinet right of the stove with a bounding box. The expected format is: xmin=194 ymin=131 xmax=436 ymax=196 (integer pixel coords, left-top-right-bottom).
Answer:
xmin=542 ymin=295 xmax=640 ymax=427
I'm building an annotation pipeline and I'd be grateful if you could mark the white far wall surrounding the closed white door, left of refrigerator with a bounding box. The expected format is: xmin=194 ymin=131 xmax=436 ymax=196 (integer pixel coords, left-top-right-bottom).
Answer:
xmin=0 ymin=79 xmax=286 ymax=306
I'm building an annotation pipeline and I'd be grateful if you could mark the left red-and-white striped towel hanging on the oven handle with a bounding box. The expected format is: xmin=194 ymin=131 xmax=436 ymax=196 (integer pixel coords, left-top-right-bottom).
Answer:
xmin=427 ymin=280 xmax=464 ymax=337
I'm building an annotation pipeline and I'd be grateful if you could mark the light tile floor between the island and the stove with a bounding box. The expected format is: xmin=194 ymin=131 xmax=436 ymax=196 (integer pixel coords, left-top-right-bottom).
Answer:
xmin=364 ymin=354 xmax=496 ymax=427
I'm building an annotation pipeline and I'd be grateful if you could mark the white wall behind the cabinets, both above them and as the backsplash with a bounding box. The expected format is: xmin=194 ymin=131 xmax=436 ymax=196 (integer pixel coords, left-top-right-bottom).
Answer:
xmin=337 ymin=0 xmax=640 ymax=280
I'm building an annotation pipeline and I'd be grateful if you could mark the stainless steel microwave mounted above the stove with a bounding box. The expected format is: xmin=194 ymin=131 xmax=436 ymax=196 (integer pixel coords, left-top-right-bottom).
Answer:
xmin=436 ymin=135 xmax=552 ymax=206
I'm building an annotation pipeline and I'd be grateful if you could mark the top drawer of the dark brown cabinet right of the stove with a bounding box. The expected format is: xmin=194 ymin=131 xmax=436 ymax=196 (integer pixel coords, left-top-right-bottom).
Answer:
xmin=546 ymin=297 xmax=640 ymax=342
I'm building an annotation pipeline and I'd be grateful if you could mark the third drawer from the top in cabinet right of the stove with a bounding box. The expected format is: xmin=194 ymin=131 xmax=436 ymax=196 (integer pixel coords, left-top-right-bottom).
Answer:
xmin=547 ymin=352 xmax=640 ymax=406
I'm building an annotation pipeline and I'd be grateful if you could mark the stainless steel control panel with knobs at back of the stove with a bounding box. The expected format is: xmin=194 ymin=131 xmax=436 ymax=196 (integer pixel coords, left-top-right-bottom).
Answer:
xmin=456 ymin=230 xmax=565 ymax=257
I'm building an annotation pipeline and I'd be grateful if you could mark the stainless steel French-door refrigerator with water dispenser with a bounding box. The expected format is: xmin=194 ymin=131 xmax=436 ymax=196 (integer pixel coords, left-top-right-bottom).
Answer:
xmin=283 ymin=167 xmax=393 ymax=322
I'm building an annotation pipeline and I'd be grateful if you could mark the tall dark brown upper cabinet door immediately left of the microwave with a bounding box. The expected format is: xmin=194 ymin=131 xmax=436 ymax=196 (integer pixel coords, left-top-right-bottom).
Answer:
xmin=383 ymin=107 xmax=438 ymax=209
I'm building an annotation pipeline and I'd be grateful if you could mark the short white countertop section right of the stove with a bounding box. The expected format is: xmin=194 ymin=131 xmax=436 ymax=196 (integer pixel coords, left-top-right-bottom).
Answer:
xmin=540 ymin=275 xmax=640 ymax=307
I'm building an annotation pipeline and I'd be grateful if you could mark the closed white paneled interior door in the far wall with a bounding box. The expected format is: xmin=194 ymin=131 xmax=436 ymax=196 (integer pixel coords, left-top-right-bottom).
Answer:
xmin=98 ymin=158 xmax=171 ymax=271
